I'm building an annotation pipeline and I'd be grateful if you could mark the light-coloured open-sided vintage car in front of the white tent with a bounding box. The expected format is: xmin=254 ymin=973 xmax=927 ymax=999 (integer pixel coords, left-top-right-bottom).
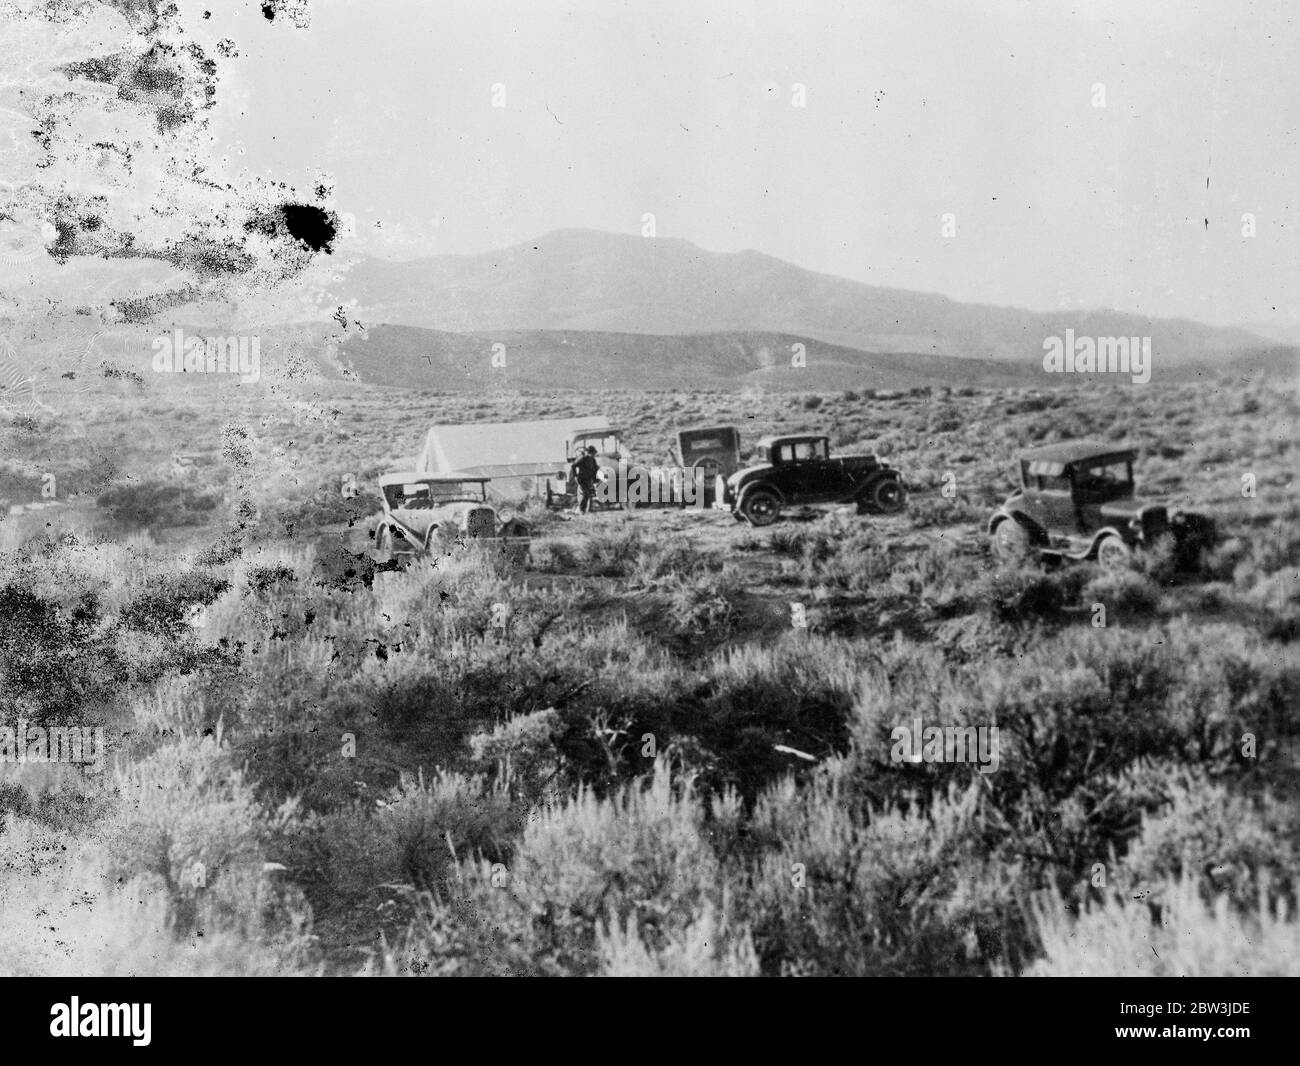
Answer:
xmin=372 ymin=471 xmax=530 ymax=562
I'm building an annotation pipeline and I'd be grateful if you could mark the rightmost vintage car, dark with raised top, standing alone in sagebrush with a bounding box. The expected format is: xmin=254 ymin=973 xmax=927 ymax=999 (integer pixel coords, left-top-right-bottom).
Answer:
xmin=988 ymin=441 xmax=1214 ymax=569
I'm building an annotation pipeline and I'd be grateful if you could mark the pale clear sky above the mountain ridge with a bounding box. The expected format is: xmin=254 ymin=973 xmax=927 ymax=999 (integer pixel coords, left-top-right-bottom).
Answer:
xmin=195 ymin=0 xmax=1300 ymax=328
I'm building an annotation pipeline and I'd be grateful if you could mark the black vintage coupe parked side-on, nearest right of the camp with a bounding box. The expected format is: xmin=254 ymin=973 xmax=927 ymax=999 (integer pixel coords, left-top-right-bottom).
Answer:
xmin=714 ymin=434 xmax=907 ymax=525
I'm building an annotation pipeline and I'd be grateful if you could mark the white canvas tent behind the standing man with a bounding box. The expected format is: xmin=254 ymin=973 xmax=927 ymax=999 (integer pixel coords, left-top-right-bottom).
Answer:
xmin=416 ymin=415 xmax=614 ymax=478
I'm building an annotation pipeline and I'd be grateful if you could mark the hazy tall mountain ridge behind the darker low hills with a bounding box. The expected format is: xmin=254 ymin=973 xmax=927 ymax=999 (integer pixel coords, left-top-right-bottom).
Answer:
xmin=342 ymin=228 xmax=1270 ymax=365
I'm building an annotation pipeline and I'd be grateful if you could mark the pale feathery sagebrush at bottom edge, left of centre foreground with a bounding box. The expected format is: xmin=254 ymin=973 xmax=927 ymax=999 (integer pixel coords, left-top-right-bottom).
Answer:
xmin=371 ymin=761 xmax=746 ymax=975
